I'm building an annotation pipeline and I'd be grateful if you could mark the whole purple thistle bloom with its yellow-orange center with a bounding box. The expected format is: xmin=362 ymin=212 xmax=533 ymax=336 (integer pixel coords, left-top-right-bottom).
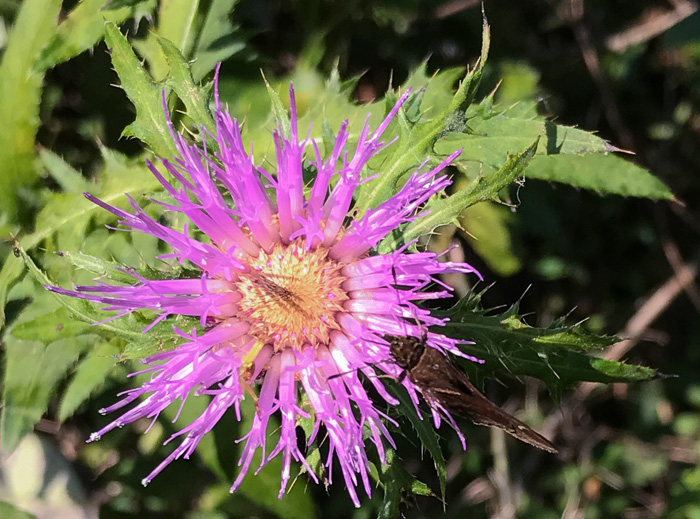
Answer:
xmin=48 ymin=75 xmax=479 ymax=506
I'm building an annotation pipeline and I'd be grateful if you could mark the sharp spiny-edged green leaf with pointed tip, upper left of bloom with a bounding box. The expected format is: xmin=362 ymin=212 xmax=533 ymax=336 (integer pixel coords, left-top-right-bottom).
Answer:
xmin=105 ymin=22 xmax=177 ymax=158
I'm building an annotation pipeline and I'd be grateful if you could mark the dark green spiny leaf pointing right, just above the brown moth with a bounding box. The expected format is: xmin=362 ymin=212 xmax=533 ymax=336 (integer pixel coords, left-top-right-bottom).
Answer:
xmin=438 ymin=293 xmax=656 ymax=398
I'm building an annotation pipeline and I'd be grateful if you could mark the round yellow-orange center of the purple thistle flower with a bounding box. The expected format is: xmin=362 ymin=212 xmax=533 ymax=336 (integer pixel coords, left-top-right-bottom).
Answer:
xmin=235 ymin=239 xmax=348 ymax=351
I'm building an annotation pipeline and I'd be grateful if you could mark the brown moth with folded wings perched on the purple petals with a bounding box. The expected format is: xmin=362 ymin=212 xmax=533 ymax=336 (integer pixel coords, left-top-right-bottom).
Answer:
xmin=384 ymin=335 xmax=557 ymax=453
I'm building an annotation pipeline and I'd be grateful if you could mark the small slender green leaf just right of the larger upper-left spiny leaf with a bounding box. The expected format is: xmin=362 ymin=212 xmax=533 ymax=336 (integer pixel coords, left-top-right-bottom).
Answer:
xmin=158 ymin=36 xmax=216 ymax=134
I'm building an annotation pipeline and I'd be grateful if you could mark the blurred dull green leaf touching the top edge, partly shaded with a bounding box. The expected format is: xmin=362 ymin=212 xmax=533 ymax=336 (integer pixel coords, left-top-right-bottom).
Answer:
xmin=192 ymin=0 xmax=246 ymax=81
